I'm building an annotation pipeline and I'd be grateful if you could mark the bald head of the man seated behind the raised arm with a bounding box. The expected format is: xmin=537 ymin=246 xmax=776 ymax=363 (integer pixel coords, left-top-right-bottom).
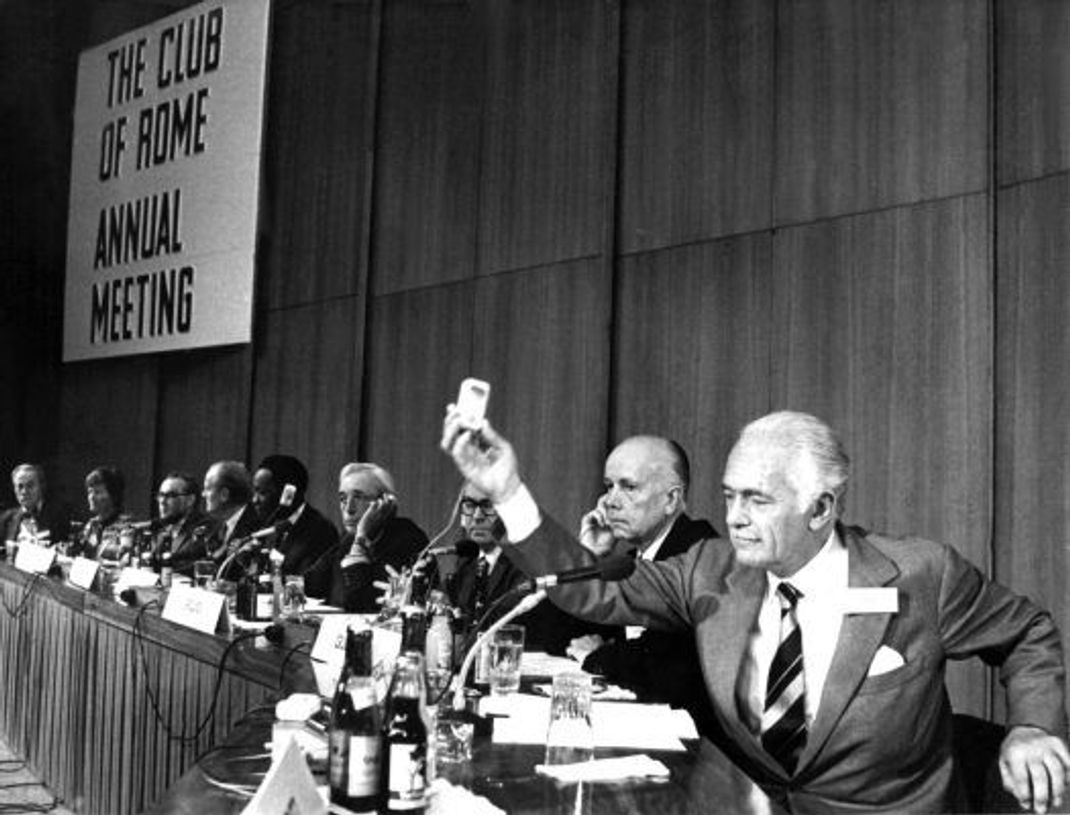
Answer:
xmin=599 ymin=435 xmax=690 ymax=548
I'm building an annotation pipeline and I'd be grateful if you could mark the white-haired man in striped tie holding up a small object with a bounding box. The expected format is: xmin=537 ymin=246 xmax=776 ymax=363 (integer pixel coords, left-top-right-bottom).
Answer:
xmin=442 ymin=409 xmax=1070 ymax=812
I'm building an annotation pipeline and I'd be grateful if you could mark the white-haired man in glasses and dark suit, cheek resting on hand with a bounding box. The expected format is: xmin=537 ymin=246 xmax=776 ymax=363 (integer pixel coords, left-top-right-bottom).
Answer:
xmin=305 ymin=462 xmax=427 ymax=613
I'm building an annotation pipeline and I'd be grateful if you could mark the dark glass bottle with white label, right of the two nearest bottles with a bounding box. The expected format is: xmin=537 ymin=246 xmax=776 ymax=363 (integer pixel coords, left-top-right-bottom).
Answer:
xmin=382 ymin=650 xmax=428 ymax=815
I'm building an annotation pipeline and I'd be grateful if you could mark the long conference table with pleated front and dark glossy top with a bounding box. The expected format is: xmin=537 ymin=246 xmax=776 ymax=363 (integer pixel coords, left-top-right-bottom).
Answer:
xmin=0 ymin=562 xmax=783 ymax=815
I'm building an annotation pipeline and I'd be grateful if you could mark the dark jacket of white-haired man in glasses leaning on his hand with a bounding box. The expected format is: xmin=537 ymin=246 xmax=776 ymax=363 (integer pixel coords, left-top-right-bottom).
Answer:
xmin=305 ymin=517 xmax=427 ymax=614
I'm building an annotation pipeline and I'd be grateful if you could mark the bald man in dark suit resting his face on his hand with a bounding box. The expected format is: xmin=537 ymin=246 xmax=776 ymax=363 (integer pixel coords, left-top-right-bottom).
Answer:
xmin=568 ymin=435 xmax=718 ymax=731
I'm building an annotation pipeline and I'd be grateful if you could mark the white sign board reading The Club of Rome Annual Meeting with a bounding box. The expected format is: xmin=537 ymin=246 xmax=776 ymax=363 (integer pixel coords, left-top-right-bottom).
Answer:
xmin=63 ymin=0 xmax=270 ymax=362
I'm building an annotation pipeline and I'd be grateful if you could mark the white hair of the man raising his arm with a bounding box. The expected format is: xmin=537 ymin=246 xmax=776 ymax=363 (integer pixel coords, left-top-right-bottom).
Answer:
xmin=739 ymin=411 xmax=851 ymax=503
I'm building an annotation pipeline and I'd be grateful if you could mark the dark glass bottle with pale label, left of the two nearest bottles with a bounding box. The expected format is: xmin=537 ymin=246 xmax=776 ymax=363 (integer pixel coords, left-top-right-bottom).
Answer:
xmin=327 ymin=628 xmax=383 ymax=813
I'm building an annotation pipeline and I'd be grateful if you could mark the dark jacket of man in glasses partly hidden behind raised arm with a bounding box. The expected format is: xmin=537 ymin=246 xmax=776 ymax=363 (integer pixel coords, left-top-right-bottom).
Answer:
xmin=446 ymin=544 xmax=623 ymax=655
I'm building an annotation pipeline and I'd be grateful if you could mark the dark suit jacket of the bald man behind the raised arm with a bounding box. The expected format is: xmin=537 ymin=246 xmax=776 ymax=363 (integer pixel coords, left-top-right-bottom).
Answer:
xmin=583 ymin=514 xmax=729 ymax=733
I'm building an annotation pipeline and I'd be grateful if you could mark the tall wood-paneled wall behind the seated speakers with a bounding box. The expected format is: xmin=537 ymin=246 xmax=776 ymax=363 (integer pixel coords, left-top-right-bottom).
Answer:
xmin=0 ymin=0 xmax=1070 ymax=712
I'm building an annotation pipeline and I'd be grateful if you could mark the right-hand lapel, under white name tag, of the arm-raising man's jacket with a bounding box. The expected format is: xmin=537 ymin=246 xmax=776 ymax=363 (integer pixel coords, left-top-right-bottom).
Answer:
xmin=796 ymin=526 xmax=899 ymax=772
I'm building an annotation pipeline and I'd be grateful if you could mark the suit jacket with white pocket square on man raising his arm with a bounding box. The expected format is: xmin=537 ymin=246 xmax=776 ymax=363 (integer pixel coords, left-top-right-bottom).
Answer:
xmin=505 ymin=519 xmax=1066 ymax=812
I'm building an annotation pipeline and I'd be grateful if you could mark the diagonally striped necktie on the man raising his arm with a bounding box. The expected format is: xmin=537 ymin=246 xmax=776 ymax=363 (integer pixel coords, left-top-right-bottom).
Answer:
xmin=762 ymin=583 xmax=806 ymax=774
